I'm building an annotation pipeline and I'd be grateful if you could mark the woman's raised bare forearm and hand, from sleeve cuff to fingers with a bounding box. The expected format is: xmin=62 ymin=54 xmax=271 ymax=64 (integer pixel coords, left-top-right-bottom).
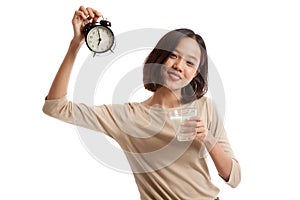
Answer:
xmin=47 ymin=6 xmax=101 ymax=100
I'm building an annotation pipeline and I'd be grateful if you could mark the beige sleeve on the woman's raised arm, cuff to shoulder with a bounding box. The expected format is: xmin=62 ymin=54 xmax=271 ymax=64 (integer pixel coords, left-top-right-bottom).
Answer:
xmin=43 ymin=96 xmax=120 ymax=139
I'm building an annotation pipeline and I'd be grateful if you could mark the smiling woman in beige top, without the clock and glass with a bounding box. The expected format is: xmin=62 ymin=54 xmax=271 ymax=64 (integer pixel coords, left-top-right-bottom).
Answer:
xmin=43 ymin=6 xmax=240 ymax=200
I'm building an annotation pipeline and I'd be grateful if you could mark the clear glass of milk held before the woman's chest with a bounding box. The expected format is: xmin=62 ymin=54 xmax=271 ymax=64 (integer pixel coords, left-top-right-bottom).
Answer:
xmin=169 ymin=107 xmax=198 ymax=142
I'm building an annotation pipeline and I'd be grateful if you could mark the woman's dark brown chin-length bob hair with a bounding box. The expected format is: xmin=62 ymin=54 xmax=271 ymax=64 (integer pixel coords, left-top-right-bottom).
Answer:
xmin=143 ymin=29 xmax=208 ymax=104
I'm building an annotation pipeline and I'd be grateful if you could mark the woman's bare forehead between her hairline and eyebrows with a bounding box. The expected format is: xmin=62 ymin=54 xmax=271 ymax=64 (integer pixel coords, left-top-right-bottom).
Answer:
xmin=175 ymin=37 xmax=201 ymax=60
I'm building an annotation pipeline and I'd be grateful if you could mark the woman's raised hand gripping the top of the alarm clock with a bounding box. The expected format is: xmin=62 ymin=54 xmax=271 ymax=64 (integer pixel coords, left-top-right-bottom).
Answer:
xmin=72 ymin=6 xmax=102 ymax=44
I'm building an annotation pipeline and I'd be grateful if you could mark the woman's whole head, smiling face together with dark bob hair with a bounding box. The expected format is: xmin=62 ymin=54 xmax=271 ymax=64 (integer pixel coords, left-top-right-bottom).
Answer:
xmin=143 ymin=28 xmax=208 ymax=103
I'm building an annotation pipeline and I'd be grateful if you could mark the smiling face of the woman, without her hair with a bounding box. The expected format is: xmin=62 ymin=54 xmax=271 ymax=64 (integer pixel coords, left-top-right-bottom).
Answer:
xmin=163 ymin=37 xmax=201 ymax=92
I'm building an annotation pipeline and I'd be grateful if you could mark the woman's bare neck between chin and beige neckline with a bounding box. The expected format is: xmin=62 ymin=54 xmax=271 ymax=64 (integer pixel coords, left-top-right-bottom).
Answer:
xmin=144 ymin=87 xmax=181 ymax=108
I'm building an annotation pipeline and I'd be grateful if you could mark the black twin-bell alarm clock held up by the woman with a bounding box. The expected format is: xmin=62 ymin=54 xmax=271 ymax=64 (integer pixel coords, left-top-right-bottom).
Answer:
xmin=83 ymin=20 xmax=115 ymax=54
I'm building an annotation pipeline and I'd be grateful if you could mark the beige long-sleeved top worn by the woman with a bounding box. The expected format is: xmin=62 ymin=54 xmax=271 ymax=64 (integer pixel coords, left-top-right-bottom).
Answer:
xmin=43 ymin=97 xmax=241 ymax=200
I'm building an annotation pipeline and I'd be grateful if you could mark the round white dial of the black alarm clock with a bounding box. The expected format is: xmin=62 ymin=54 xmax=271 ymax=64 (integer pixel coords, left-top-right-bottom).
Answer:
xmin=85 ymin=26 xmax=114 ymax=53
